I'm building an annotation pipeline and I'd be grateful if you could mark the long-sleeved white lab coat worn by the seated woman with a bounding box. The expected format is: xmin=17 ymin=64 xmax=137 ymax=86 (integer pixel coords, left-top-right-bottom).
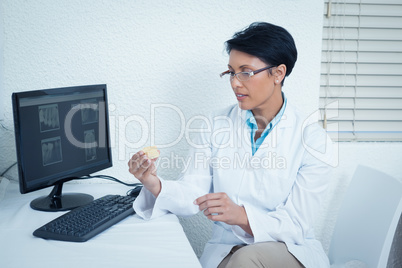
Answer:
xmin=134 ymin=101 xmax=334 ymax=268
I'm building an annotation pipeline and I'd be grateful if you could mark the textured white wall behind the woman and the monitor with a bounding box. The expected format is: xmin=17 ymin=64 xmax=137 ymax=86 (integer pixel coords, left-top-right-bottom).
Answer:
xmin=0 ymin=0 xmax=402 ymax=266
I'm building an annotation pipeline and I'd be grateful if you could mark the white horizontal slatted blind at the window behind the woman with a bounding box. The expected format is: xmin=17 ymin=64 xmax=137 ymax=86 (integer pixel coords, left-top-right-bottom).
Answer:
xmin=320 ymin=0 xmax=402 ymax=141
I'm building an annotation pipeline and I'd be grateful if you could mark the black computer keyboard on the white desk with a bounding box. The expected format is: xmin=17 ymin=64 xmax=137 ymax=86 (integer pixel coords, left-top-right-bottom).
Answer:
xmin=33 ymin=195 xmax=135 ymax=242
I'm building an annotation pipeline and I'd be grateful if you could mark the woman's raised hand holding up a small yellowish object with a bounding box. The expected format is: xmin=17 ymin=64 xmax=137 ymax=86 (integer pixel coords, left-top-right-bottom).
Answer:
xmin=128 ymin=151 xmax=162 ymax=197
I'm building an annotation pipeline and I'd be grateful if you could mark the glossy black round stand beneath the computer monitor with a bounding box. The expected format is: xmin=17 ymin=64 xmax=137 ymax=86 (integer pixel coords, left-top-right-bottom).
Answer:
xmin=31 ymin=182 xmax=94 ymax=211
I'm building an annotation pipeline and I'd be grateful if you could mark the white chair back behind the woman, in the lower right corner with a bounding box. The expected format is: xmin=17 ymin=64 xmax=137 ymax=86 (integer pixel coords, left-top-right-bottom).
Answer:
xmin=328 ymin=166 xmax=402 ymax=268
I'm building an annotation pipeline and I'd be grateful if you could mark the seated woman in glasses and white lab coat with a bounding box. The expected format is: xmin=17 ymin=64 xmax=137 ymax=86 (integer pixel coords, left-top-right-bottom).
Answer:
xmin=129 ymin=23 xmax=333 ymax=268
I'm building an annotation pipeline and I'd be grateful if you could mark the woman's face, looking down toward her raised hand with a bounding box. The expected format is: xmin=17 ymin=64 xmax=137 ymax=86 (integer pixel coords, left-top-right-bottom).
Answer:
xmin=228 ymin=49 xmax=282 ymax=112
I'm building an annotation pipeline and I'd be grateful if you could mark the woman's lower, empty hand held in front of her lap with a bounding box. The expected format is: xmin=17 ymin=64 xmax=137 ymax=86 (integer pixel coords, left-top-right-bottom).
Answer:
xmin=194 ymin=193 xmax=252 ymax=235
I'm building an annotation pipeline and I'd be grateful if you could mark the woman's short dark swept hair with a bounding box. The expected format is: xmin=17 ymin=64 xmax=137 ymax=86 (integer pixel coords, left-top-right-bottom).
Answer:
xmin=225 ymin=22 xmax=297 ymax=84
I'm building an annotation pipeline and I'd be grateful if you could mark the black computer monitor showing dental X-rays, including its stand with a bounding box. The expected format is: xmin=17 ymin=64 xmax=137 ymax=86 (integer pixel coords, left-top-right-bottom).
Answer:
xmin=12 ymin=85 xmax=112 ymax=211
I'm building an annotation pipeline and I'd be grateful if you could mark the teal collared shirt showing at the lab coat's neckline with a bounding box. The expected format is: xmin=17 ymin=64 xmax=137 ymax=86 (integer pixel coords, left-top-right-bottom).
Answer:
xmin=246 ymin=92 xmax=287 ymax=155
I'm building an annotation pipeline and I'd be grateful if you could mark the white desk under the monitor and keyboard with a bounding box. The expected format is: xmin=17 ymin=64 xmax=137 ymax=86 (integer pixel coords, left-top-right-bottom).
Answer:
xmin=0 ymin=179 xmax=201 ymax=268
